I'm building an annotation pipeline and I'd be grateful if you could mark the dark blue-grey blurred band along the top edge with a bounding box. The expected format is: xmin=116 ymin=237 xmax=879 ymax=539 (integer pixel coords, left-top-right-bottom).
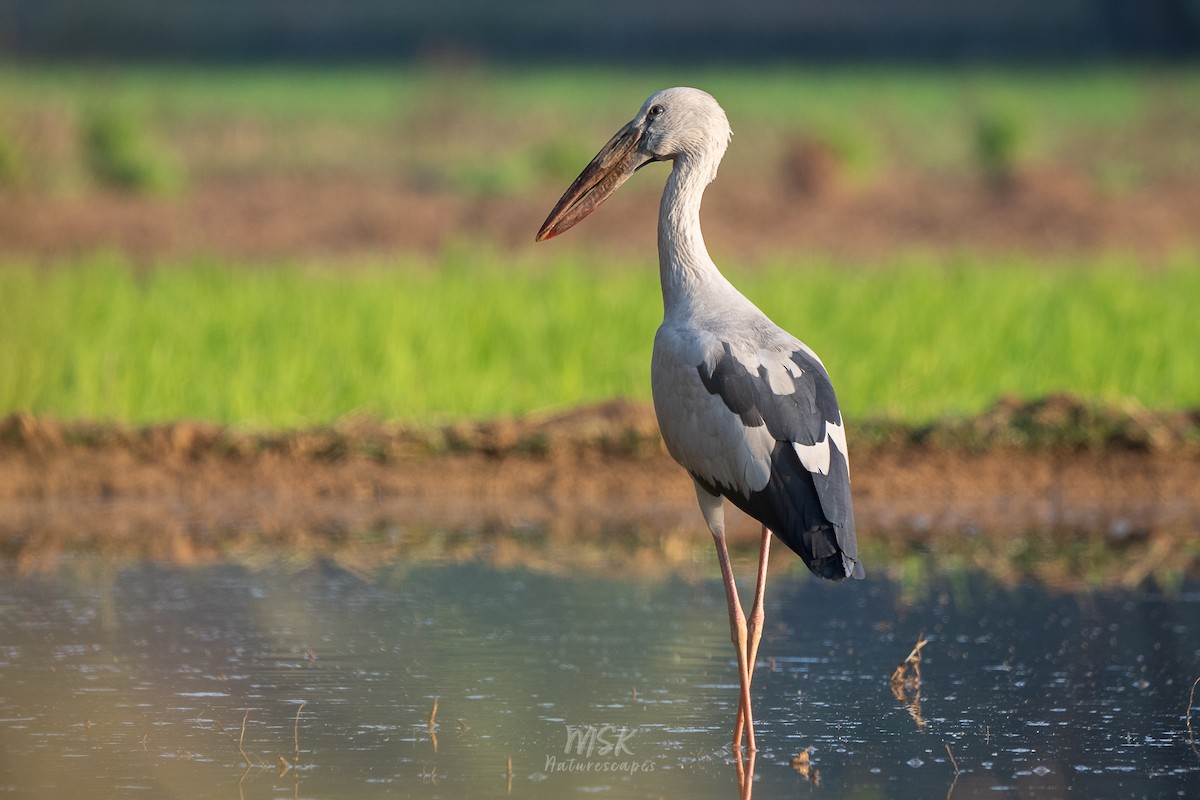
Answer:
xmin=2 ymin=0 xmax=1200 ymax=64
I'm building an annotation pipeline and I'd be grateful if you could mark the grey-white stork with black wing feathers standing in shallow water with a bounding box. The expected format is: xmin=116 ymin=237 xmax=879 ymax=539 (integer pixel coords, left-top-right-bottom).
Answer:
xmin=536 ymin=88 xmax=863 ymax=754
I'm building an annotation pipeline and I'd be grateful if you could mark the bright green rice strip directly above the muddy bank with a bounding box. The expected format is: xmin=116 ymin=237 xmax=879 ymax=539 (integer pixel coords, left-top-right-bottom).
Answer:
xmin=0 ymin=255 xmax=1200 ymax=426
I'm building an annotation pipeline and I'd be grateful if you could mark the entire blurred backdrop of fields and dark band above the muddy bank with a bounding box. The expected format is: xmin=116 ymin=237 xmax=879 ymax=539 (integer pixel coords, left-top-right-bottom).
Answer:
xmin=0 ymin=0 xmax=1200 ymax=426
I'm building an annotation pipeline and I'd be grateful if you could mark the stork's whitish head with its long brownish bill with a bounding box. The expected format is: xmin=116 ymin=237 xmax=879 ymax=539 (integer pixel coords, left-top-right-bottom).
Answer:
xmin=536 ymin=86 xmax=733 ymax=241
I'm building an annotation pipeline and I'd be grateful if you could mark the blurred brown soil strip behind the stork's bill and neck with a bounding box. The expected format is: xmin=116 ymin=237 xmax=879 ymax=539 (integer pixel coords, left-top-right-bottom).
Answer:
xmin=7 ymin=169 xmax=1200 ymax=264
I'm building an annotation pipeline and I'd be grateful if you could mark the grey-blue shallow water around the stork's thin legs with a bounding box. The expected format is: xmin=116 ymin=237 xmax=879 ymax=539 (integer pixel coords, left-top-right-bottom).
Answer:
xmin=0 ymin=559 xmax=1200 ymax=798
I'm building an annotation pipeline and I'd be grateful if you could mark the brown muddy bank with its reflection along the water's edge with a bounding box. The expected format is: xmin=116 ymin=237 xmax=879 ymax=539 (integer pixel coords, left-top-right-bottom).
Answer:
xmin=0 ymin=398 xmax=1200 ymax=583
